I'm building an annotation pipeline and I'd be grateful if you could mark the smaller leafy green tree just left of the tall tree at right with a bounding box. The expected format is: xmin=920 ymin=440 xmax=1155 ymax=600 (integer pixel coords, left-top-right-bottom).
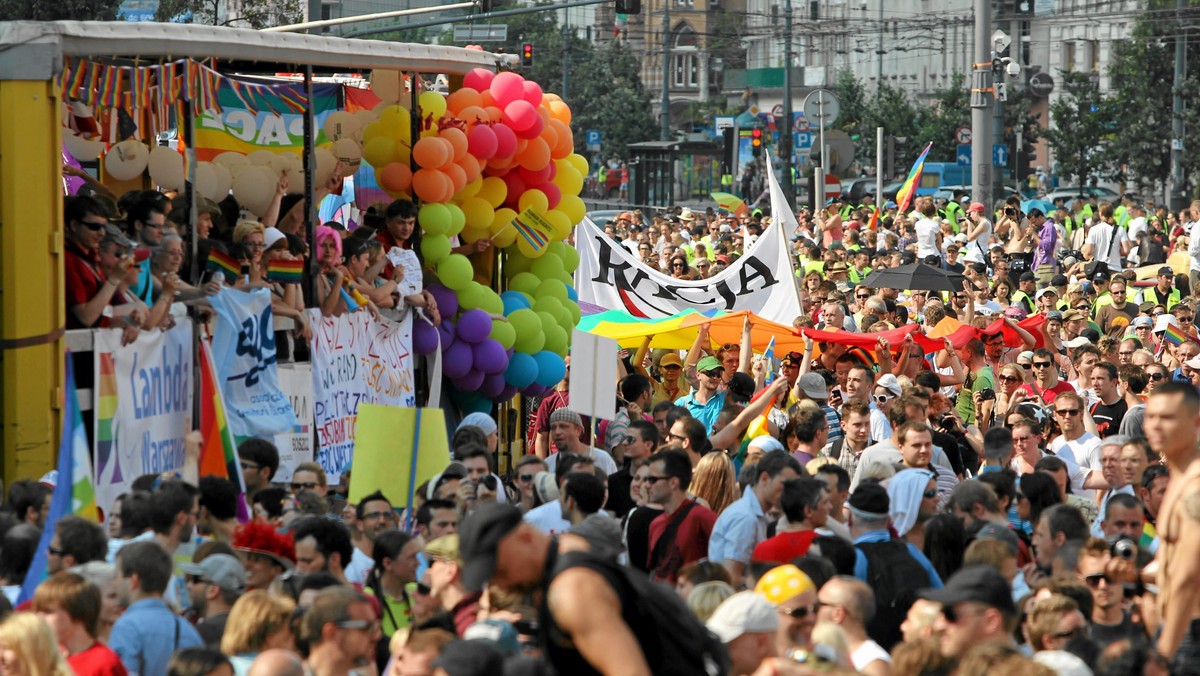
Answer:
xmin=1040 ymin=72 xmax=1109 ymax=190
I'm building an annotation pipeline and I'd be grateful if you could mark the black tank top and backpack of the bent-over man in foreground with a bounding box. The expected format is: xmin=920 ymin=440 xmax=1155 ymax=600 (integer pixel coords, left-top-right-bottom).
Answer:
xmin=538 ymin=543 xmax=732 ymax=676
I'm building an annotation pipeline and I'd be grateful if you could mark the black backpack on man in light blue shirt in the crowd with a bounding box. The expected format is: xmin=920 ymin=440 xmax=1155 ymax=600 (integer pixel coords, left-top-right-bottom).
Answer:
xmin=854 ymin=540 xmax=931 ymax=651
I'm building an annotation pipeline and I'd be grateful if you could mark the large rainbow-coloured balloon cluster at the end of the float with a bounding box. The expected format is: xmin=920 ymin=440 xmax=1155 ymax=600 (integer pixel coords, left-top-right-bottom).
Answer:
xmin=362 ymin=68 xmax=588 ymax=409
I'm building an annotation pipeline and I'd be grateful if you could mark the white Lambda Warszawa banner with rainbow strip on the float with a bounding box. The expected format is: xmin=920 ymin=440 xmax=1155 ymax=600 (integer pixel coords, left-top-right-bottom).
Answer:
xmin=92 ymin=322 xmax=194 ymax=512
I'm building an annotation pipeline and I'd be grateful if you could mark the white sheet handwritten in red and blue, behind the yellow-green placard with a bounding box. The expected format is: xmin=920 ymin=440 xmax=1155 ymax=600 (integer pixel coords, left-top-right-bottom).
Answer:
xmin=310 ymin=310 xmax=416 ymax=483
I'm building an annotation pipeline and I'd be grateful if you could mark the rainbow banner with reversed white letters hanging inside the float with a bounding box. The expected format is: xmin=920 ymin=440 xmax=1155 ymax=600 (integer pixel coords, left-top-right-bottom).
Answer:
xmin=196 ymin=79 xmax=342 ymax=161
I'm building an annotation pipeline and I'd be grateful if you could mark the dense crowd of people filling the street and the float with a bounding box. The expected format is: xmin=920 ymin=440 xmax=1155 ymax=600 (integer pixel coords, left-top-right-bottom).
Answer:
xmin=7 ymin=171 xmax=1200 ymax=676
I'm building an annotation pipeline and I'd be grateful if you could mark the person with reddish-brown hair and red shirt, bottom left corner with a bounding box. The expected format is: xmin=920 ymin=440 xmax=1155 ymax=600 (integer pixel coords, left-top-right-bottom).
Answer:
xmin=34 ymin=572 xmax=126 ymax=676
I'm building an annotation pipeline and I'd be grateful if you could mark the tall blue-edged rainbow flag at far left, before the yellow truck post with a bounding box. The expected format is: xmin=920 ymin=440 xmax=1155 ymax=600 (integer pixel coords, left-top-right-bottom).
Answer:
xmin=17 ymin=349 xmax=100 ymax=603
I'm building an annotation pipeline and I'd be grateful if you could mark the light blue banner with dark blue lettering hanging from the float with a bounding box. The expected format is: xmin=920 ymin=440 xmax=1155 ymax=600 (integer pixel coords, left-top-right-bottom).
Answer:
xmin=209 ymin=287 xmax=296 ymax=443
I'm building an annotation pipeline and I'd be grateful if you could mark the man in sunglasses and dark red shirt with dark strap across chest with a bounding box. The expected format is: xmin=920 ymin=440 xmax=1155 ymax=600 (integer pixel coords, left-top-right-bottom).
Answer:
xmin=646 ymin=450 xmax=716 ymax=585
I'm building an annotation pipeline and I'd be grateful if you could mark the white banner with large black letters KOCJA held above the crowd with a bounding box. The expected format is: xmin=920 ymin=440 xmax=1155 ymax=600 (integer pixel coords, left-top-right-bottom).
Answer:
xmin=575 ymin=219 xmax=800 ymax=325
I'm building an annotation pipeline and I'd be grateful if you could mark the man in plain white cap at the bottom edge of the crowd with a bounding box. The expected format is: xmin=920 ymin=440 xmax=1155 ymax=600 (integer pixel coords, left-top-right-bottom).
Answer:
xmin=707 ymin=591 xmax=779 ymax=676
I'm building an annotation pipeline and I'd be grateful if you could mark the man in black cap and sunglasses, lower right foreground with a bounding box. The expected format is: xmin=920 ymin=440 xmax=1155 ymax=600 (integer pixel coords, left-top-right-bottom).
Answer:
xmin=920 ymin=566 xmax=1019 ymax=659
